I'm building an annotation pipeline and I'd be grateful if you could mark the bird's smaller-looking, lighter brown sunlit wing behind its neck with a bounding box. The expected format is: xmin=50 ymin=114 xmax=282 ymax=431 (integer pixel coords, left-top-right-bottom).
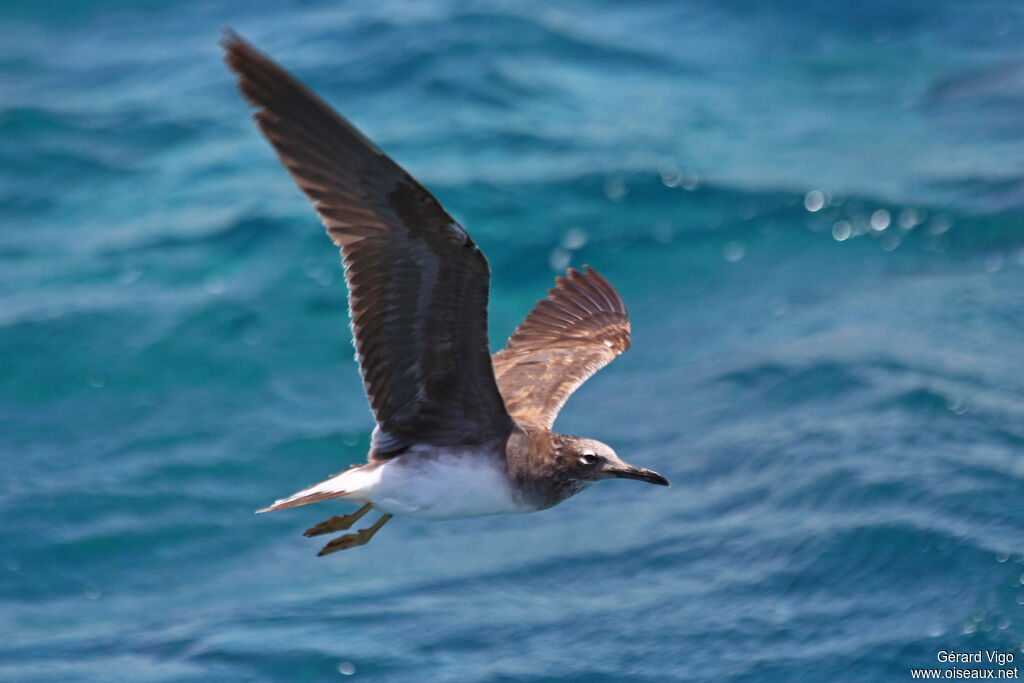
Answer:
xmin=494 ymin=267 xmax=630 ymax=429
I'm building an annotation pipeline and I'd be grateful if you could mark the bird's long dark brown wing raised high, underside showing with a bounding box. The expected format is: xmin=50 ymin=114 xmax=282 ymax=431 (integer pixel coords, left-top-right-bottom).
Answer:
xmin=222 ymin=33 xmax=513 ymax=458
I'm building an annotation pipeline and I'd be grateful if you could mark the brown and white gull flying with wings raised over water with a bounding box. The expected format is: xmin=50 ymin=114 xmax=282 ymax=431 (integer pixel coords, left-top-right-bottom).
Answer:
xmin=221 ymin=31 xmax=669 ymax=555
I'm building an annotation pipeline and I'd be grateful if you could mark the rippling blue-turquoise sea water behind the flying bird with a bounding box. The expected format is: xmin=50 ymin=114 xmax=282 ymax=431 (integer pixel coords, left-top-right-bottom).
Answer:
xmin=0 ymin=0 xmax=1024 ymax=681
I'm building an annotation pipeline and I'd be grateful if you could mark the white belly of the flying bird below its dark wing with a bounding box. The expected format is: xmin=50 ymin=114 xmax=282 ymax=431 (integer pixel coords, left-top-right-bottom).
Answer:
xmin=339 ymin=446 xmax=529 ymax=519
